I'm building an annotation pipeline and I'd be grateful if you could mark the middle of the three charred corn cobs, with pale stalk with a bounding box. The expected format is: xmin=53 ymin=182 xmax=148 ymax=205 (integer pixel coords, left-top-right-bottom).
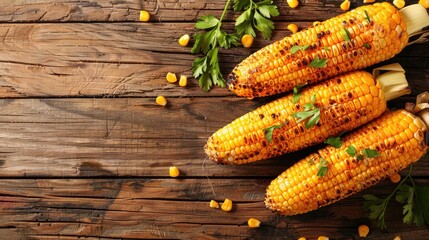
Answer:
xmin=205 ymin=64 xmax=409 ymax=164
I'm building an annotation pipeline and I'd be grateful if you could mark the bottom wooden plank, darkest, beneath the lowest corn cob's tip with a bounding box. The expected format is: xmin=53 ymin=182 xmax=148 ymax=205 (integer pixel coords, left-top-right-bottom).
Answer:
xmin=0 ymin=179 xmax=428 ymax=239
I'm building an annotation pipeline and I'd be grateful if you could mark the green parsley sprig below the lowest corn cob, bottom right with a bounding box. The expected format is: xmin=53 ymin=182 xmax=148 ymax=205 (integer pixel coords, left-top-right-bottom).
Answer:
xmin=363 ymin=165 xmax=429 ymax=229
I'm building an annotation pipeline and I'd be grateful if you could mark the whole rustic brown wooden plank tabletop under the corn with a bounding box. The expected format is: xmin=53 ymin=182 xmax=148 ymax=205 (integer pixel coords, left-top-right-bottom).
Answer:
xmin=0 ymin=0 xmax=429 ymax=239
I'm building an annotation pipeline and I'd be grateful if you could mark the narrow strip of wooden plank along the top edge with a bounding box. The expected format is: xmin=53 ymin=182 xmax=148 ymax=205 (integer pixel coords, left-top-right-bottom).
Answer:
xmin=0 ymin=0 xmax=418 ymax=22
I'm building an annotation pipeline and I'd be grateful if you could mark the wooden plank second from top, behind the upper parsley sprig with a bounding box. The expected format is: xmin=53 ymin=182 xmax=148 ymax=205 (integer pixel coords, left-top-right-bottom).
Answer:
xmin=0 ymin=23 xmax=429 ymax=97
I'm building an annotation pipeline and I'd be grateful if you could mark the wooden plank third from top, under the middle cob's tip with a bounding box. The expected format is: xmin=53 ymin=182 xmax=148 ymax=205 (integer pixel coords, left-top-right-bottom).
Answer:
xmin=0 ymin=98 xmax=429 ymax=177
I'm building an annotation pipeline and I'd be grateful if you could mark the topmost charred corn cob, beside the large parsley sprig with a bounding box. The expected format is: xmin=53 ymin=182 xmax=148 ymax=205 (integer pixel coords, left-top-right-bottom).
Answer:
xmin=227 ymin=2 xmax=429 ymax=99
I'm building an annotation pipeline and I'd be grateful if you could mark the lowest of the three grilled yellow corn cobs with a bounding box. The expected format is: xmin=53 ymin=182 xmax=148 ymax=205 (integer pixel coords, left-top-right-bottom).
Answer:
xmin=265 ymin=110 xmax=429 ymax=215
